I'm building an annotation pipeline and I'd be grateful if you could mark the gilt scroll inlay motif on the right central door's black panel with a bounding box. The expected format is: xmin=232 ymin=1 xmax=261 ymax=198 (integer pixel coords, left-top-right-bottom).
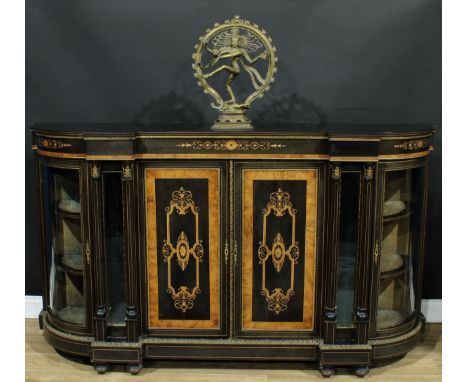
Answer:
xmin=258 ymin=188 xmax=299 ymax=315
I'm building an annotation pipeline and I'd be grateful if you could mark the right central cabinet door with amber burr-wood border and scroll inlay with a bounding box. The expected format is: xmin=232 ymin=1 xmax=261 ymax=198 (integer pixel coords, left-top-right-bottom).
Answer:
xmin=234 ymin=163 xmax=320 ymax=337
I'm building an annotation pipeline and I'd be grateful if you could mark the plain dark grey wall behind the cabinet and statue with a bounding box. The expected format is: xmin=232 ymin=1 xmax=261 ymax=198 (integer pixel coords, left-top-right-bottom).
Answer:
xmin=26 ymin=0 xmax=442 ymax=298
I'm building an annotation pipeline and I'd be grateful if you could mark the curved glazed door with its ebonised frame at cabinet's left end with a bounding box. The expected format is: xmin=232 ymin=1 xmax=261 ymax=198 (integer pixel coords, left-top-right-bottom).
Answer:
xmin=39 ymin=160 xmax=91 ymax=333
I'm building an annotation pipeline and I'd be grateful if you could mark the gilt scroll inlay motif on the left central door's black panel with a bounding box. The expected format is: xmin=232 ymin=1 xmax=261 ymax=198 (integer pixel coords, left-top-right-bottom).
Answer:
xmin=162 ymin=187 xmax=204 ymax=313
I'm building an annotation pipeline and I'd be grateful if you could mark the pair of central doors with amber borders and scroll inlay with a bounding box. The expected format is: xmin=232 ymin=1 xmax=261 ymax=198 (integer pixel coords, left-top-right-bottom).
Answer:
xmin=144 ymin=161 xmax=323 ymax=338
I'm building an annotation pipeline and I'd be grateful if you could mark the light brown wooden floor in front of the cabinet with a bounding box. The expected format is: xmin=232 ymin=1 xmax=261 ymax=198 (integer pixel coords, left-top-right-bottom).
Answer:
xmin=26 ymin=319 xmax=442 ymax=382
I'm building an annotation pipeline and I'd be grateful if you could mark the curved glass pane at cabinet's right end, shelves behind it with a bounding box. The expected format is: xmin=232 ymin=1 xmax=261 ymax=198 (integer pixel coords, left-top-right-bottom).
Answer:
xmin=377 ymin=168 xmax=422 ymax=329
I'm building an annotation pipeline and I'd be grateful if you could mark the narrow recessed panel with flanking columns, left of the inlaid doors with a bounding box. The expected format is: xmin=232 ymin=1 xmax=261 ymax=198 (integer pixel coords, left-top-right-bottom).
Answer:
xmin=88 ymin=161 xmax=133 ymax=342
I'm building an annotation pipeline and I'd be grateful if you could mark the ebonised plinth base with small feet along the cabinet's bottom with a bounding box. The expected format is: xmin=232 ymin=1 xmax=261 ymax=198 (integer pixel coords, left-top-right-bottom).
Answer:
xmin=40 ymin=311 xmax=422 ymax=377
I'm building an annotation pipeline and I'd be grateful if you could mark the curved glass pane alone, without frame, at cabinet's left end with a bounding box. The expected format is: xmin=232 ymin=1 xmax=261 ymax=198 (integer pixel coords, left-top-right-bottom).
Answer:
xmin=42 ymin=166 xmax=86 ymax=326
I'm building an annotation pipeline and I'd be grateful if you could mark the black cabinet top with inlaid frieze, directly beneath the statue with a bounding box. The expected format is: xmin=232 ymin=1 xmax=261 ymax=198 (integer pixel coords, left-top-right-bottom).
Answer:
xmin=32 ymin=123 xmax=434 ymax=162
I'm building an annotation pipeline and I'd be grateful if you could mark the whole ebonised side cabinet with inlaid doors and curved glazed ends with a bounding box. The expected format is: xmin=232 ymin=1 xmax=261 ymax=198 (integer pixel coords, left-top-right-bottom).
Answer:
xmin=33 ymin=125 xmax=433 ymax=376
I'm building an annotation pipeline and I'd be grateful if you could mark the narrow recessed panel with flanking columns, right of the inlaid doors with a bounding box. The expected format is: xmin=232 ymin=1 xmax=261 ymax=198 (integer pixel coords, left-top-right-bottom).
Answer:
xmin=322 ymin=162 xmax=375 ymax=344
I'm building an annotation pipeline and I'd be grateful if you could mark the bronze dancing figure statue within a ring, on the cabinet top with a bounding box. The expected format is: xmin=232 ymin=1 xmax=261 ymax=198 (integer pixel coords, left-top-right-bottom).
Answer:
xmin=192 ymin=16 xmax=277 ymax=130
